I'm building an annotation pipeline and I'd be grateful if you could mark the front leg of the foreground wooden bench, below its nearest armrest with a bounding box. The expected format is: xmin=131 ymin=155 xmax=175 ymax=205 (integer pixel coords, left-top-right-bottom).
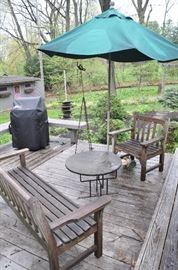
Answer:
xmin=94 ymin=210 xmax=103 ymax=258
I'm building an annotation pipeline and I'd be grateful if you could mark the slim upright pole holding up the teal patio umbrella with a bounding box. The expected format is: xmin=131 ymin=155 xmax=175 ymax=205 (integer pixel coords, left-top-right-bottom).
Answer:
xmin=107 ymin=54 xmax=112 ymax=151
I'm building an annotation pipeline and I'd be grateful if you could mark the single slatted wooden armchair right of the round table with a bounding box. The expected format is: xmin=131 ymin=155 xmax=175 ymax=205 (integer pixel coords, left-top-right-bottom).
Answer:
xmin=109 ymin=114 xmax=169 ymax=181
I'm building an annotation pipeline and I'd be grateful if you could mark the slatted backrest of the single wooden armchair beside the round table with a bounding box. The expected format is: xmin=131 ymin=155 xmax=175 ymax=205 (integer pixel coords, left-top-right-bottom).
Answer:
xmin=132 ymin=114 xmax=169 ymax=142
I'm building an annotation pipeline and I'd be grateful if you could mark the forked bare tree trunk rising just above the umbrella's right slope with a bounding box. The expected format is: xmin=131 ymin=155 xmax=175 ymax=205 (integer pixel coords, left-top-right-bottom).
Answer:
xmin=132 ymin=0 xmax=152 ymax=24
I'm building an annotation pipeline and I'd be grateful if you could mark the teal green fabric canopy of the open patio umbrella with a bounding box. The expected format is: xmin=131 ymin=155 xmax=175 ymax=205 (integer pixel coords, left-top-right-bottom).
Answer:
xmin=39 ymin=8 xmax=178 ymax=62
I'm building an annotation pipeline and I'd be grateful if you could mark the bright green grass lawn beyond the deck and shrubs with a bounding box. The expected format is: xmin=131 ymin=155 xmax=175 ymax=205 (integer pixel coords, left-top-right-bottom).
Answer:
xmin=0 ymin=87 xmax=172 ymax=144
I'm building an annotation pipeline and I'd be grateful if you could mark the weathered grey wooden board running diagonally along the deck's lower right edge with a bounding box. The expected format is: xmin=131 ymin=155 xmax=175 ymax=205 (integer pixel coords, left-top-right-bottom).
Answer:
xmin=135 ymin=151 xmax=178 ymax=270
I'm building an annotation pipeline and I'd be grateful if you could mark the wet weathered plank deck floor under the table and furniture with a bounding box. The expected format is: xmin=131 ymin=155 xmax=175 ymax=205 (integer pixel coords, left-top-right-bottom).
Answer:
xmin=0 ymin=142 xmax=172 ymax=270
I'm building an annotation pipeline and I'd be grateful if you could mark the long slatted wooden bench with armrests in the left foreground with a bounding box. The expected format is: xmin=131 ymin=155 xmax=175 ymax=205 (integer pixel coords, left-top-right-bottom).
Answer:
xmin=0 ymin=149 xmax=111 ymax=270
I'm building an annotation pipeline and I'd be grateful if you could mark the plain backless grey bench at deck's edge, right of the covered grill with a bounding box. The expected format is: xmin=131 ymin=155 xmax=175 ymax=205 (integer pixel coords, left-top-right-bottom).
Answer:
xmin=48 ymin=118 xmax=87 ymax=144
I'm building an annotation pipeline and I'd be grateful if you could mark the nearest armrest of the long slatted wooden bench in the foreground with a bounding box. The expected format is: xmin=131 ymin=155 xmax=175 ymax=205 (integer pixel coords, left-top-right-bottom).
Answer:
xmin=49 ymin=196 xmax=111 ymax=230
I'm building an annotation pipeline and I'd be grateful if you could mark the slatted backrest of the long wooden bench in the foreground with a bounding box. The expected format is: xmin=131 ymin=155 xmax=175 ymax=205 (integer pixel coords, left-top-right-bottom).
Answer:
xmin=0 ymin=169 xmax=50 ymax=245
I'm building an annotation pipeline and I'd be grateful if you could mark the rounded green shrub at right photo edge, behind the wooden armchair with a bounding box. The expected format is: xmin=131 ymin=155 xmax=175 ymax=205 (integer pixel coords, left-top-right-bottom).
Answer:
xmin=159 ymin=88 xmax=178 ymax=109
